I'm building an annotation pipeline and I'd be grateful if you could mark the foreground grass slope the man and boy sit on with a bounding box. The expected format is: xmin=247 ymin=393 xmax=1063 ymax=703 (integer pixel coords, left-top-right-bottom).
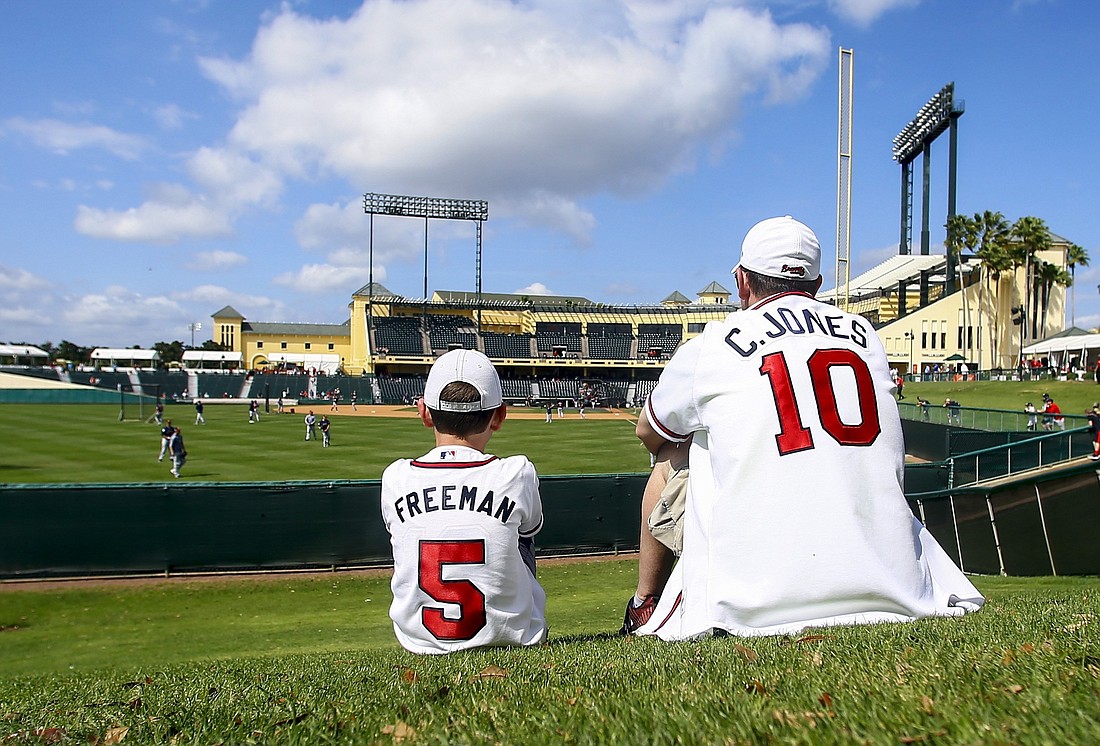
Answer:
xmin=0 ymin=560 xmax=1100 ymax=744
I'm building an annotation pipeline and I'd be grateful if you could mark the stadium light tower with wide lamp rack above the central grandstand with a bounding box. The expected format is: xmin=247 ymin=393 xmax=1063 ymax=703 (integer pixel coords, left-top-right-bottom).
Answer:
xmin=363 ymin=191 xmax=488 ymax=358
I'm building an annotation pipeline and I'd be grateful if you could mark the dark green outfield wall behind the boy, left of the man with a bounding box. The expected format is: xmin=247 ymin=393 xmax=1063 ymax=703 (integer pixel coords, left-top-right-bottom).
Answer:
xmin=0 ymin=474 xmax=648 ymax=579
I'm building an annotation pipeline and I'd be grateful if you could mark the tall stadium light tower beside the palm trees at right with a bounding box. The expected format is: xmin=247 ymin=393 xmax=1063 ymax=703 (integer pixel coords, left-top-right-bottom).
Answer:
xmin=893 ymin=83 xmax=966 ymax=303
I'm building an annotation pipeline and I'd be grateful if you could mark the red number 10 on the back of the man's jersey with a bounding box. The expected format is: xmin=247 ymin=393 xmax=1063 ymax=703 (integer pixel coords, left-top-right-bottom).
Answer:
xmin=760 ymin=349 xmax=881 ymax=456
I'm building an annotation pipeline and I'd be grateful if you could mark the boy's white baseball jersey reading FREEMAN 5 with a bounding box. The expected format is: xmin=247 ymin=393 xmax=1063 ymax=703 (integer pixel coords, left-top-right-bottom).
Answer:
xmin=382 ymin=446 xmax=547 ymax=654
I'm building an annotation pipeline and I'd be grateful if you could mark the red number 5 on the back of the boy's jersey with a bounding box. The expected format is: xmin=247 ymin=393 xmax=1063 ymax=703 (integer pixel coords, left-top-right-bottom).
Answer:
xmin=419 ymin=539 xmax=485 ymax=640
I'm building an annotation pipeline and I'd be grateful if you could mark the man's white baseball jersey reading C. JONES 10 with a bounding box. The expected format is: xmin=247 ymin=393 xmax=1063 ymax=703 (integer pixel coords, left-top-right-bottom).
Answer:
xmin=640 ymin=293 xmax=983 ymax=639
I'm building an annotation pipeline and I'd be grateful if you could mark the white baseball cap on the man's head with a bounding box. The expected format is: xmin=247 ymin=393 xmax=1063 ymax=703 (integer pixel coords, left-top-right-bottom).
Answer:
xmin=734 ymin=215 xmax=822 ymax=279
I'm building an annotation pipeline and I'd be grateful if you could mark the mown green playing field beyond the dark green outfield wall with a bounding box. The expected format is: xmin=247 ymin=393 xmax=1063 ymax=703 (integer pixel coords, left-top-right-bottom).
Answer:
xmin=0 ymin=404 xmax=649 ymax=483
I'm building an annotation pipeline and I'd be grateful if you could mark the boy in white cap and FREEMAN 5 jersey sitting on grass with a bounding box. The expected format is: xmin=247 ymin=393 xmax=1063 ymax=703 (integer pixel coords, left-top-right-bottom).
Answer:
xmin=382 ymin=350 xmax=548 ymax=654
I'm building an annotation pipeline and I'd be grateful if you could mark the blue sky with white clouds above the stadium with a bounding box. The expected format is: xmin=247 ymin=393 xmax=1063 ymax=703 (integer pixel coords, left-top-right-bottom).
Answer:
xmin=0 ymin=0 xmax=1100 ymax=347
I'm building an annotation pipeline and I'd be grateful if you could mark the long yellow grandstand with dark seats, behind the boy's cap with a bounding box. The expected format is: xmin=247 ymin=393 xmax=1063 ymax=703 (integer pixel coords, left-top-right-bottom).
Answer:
xmin=213 ymin=282 xmax=736 ymax=405
